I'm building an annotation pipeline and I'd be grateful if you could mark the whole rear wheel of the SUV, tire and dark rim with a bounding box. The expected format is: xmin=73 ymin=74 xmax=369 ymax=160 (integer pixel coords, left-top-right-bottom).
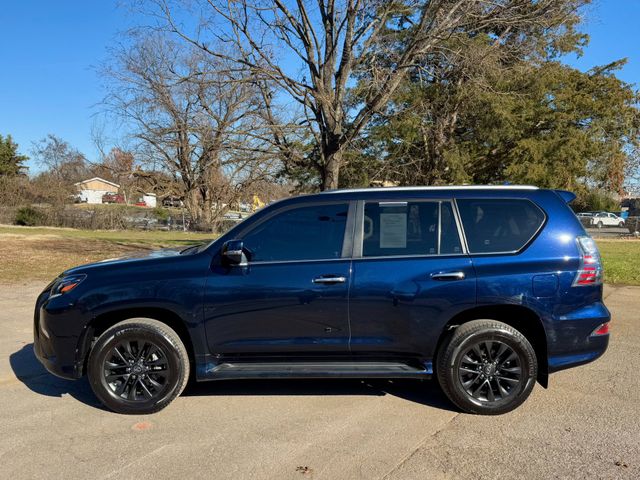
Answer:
xmin=436 ymin=320 xmax=538 ymax=415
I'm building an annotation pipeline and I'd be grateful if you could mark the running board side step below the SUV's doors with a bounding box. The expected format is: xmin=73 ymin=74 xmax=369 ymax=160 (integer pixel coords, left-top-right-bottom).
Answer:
xmin=207 ymin=362 xmax=432 ymax=380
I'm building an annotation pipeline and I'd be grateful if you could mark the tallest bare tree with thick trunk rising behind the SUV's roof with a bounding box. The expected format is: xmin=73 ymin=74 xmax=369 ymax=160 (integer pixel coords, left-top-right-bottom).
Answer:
xmin=147 ymin=0 xmax=571 ymax=189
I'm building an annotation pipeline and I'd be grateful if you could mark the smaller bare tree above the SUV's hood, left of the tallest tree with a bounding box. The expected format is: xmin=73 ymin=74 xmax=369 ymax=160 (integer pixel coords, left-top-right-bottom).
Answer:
xmin=105 ymin=34 xmax=278 ymax=226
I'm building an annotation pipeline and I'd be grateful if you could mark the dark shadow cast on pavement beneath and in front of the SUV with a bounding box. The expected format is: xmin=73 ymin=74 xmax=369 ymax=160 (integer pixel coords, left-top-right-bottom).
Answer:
xmin=9 ymin=343 xmax=457 ymax=411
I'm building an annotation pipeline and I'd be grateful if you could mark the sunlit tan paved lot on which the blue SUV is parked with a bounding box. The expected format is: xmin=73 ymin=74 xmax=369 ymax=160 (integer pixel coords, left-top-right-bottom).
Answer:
xmin=0 ymin=282 xmax=640 ymax=479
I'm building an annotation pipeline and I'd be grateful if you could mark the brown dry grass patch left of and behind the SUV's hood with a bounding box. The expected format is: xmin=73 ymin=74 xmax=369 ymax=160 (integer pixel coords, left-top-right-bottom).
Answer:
xmin=0 ymin=234 xmax=146 ymax=283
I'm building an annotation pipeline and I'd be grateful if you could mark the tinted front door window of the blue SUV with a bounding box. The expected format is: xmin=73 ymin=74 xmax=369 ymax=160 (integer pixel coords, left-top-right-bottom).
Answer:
xmin=243 ymin=203 xmax=349 ymax=262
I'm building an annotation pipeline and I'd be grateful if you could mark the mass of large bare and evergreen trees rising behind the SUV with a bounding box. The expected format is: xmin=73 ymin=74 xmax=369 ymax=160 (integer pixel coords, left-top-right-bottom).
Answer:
xmin=0 ymin=0 xmax=640 ymax=229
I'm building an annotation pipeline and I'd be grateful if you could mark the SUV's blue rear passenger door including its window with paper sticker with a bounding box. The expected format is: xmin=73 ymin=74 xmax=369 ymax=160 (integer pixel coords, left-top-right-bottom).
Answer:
xmin=349 ymin=199 xmax=476 ymax=359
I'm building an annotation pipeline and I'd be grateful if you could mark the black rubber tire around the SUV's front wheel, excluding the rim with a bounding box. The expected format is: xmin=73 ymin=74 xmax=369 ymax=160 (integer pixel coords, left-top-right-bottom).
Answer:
xmin=88 ymin=324 xmax=185 ymax=413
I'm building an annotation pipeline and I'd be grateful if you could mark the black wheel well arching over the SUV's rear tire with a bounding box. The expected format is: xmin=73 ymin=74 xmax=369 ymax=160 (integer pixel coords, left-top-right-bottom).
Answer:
xmin=436 ymin=305 xmax=549 ymax=388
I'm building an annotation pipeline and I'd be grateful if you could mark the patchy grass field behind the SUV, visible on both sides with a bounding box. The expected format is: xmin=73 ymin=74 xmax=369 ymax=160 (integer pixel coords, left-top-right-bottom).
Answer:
xmin=0 ymin=226 xmax=640 ymax=285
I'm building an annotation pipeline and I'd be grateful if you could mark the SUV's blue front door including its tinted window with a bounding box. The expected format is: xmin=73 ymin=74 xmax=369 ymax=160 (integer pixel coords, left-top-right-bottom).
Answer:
xmin=205 ymin=202 xmax=355 ymax=357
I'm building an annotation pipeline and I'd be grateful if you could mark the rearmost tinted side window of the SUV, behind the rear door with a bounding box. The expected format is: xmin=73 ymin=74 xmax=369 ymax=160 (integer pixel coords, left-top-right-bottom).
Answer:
xmin=457 ymin=199 xmax=545 ymax=253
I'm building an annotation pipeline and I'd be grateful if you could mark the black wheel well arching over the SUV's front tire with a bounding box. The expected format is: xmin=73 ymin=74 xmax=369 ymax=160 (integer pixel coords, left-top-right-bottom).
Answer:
xmin=80 ymin=308 xmax=195 ymax=373
